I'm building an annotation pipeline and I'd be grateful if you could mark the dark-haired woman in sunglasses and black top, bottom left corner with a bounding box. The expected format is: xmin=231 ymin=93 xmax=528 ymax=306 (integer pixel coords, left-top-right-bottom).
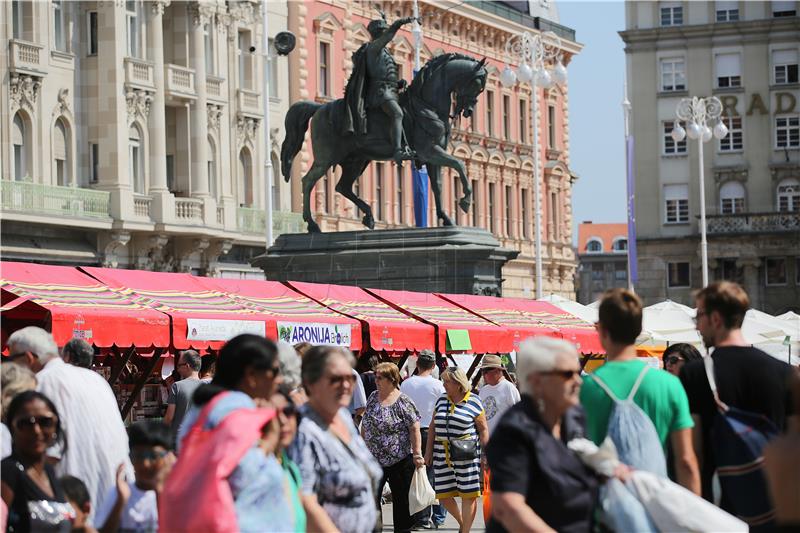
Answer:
xmin=0 ymin=391 xmax=75 ymax=532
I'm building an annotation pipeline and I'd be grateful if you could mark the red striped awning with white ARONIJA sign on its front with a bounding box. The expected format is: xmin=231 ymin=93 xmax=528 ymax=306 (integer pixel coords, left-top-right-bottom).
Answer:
xmin=194 ymin=278 xmax=361 ymax=350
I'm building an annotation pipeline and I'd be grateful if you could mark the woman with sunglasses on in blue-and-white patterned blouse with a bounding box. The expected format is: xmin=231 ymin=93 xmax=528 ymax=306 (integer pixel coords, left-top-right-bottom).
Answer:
xmin=289 ymin=346 xmax=383 ymax=533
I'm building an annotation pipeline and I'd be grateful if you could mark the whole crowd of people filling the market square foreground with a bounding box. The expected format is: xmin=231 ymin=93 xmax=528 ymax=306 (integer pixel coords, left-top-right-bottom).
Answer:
xmin=0 ymin=282 xmax=800 ymax=533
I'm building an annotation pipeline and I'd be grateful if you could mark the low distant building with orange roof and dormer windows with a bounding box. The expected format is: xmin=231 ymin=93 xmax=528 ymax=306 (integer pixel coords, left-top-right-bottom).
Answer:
xmin=576 ymin=221 xmax=628 ymax=305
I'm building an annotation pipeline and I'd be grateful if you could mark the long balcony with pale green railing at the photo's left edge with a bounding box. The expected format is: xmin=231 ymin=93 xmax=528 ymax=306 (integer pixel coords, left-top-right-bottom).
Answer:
xmin=0 ymin=180 xmax=111 ymax=222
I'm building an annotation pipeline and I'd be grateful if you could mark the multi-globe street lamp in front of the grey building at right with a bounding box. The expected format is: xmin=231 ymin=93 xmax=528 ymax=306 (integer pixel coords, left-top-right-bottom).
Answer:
xmin=671 ymin=96 xmax=728 ymax=287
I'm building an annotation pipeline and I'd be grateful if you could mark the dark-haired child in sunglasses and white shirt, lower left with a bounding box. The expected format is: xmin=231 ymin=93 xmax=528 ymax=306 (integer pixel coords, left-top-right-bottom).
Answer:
xmin=95 ymin=420 xmax=175 ymax=533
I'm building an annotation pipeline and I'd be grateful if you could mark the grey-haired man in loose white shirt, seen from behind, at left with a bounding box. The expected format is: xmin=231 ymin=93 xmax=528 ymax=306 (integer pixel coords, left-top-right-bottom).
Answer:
xmin=8 ymin=326 xmax=133 ymax=520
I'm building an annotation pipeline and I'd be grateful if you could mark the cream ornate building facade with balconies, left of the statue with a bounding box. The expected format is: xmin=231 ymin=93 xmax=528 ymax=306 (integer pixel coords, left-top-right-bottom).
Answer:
xmin=0 ymin=0 xmax=302 ymax=277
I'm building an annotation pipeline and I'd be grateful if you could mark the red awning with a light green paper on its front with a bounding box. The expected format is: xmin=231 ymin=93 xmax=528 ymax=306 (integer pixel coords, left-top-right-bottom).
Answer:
xmin=364 ymin=289 xmax=506 ymax=353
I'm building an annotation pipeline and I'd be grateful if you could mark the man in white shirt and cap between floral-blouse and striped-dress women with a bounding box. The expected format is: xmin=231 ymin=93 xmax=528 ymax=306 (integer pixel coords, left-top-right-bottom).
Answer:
xmin=400 ymin=350 xmax=446 ymax=527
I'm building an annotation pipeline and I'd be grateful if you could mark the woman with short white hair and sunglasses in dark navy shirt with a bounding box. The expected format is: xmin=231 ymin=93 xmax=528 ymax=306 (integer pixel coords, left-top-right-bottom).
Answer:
xmin=486 ymin=338 xmax=597 ymax=533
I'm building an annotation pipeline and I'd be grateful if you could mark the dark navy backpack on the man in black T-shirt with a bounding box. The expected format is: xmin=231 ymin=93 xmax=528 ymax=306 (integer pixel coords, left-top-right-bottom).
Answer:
xmin=703 ymin=357 xmax=778 ymax=531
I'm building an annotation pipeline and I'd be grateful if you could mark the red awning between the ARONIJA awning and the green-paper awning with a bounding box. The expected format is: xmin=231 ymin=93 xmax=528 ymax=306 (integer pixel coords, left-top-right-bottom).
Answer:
xmin=287 ymin=281 xmax=436 ymax=353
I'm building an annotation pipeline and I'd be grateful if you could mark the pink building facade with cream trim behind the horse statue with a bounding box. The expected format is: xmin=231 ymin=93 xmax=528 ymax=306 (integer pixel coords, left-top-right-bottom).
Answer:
xmin=288 ymin=0 xmax=581 ymax=297
